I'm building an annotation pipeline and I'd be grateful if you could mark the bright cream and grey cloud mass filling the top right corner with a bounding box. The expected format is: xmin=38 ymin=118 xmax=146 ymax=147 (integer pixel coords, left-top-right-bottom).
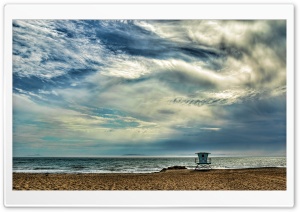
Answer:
xmin=141 ymin=20 xmax=286 ymax=88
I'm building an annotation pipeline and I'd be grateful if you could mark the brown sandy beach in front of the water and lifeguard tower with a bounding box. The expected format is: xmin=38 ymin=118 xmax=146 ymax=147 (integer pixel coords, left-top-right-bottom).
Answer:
xmin=13 ymin=168 xmax=286 ymax=190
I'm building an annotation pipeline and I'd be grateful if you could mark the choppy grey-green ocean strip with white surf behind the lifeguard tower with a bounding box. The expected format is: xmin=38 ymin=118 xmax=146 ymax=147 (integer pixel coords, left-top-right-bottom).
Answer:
xmin=13 ymin=157 xmax=286 ymax=173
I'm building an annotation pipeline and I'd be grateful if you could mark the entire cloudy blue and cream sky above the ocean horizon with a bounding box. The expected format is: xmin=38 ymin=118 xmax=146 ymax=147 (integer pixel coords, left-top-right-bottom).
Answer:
xmin=13 ymin=20 xmax=286 ymax=157
